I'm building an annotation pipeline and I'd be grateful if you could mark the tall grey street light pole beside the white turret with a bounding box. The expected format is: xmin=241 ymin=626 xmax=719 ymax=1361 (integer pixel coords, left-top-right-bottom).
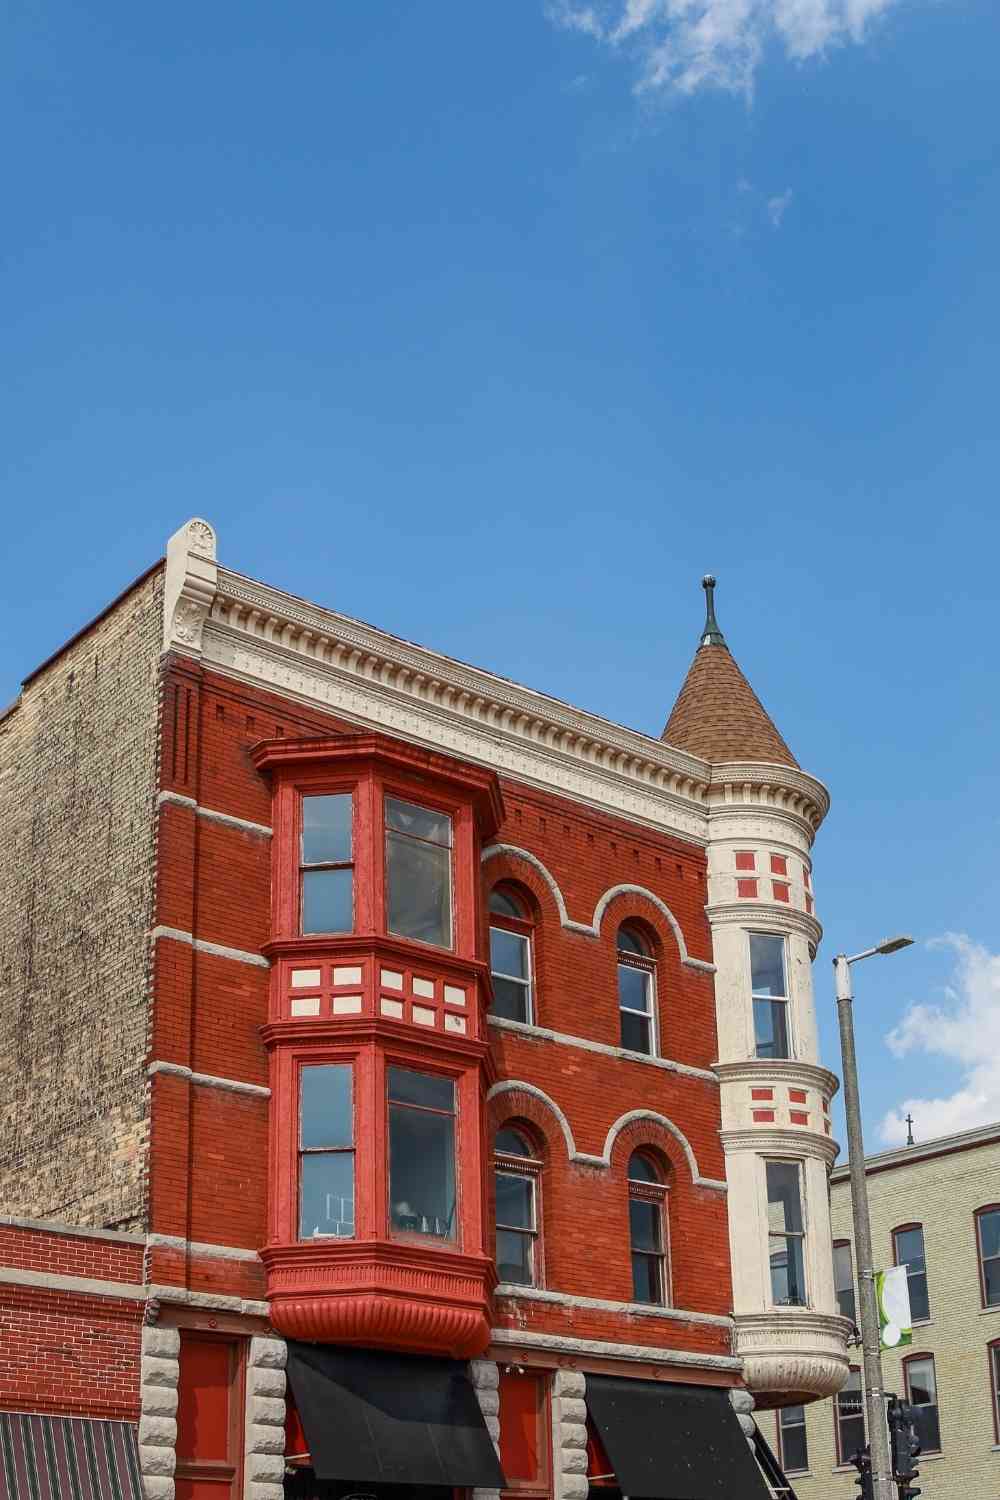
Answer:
xmin=834 ymin=938 xmax=913 ymax=1500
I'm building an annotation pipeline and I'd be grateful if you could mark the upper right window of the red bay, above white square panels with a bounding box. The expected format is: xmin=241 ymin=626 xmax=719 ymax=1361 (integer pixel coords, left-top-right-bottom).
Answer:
xmin=385 ymin=797 xmax=451 ymax=948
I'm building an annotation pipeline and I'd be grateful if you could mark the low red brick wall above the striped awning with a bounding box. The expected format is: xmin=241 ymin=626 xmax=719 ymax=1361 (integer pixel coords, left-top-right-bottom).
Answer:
xmin=0 ymin=1224 xmax=144 ymax=1421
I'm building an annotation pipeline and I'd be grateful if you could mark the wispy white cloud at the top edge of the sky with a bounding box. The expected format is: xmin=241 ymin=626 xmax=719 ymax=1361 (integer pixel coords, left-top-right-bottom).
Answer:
xmin=546 ymin=0 xmax=897 ymax=95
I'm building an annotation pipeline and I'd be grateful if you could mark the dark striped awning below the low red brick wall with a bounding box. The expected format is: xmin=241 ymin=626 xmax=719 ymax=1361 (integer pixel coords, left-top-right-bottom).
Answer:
xmin=0 ymin=1412 xmax=142 ymax=1500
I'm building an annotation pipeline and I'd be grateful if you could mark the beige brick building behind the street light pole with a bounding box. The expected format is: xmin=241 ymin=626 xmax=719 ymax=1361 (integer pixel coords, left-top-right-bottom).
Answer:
xmin=762 ymin=1124 xmax=1000 ymax=1500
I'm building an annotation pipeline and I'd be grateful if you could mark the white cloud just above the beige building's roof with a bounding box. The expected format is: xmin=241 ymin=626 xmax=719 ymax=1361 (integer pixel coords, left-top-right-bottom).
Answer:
xmin=882 ymin=933 xmax=1000 ymax=1146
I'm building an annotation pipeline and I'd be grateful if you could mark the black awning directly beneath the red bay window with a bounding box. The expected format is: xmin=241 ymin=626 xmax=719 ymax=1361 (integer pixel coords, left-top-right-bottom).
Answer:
xmin=288 ymin=1343 xmax=504 ymax=1490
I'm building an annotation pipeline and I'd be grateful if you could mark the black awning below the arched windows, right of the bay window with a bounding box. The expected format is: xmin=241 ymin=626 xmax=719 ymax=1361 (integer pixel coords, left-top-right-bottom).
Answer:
xmin=586 ymin=1376 xmax=771 ymax=1500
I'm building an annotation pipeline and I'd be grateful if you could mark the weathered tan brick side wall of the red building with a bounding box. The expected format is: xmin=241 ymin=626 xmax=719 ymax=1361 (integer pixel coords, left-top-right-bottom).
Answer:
xmin=0 ymin=572 xmax=162 ymax=1229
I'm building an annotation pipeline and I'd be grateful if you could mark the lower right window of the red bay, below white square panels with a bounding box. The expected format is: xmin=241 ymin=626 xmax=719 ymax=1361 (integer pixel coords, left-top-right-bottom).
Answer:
xmin=388 ymin=1067 xmax=456 ymax=1239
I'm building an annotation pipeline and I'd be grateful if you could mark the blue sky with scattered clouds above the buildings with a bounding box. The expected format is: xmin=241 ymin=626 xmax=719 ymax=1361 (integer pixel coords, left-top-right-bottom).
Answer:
xmin=0 ymin=0 xmax=1000 ymax=1148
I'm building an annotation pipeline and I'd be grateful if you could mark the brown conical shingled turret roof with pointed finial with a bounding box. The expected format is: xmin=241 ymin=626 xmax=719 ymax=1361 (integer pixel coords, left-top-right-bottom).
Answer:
xmin=660 ymin=576 xmax=799 ymax=768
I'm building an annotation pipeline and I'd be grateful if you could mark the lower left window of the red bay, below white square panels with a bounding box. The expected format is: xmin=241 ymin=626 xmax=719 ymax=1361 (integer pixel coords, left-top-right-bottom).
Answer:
xmin=298 ymin=1062 xmax=354 ymax=1239
